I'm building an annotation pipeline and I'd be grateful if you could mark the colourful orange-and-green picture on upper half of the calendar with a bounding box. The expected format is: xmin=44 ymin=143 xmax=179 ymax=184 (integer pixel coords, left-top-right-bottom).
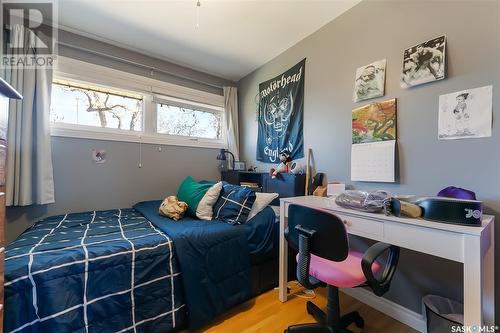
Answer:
xmin=352 ymin=98 xmax=396 ymax=144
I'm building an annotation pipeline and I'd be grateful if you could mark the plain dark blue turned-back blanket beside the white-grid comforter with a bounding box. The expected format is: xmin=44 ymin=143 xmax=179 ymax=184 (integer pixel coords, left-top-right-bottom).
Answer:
xmin=134 ymin=201 xmax=275 ymax=329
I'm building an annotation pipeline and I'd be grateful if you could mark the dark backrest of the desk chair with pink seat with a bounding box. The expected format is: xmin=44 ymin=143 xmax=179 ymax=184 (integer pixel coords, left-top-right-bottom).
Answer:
xmin=287 ymin=205 xmax=349 ymax=262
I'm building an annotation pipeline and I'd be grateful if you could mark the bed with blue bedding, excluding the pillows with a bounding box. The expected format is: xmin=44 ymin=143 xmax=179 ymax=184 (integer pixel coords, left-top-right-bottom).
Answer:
xmin=4 ymin=201 xmax=277 ymax=332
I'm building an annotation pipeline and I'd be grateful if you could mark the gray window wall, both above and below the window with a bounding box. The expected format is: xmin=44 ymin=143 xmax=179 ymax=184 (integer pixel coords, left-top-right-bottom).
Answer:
xmin=5 ymin=31 xmax=229 ymax=243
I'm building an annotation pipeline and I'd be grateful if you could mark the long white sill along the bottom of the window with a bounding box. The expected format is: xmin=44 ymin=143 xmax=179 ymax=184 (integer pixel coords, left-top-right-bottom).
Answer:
xmin=50 ymin=126 xmax=227 ymax=149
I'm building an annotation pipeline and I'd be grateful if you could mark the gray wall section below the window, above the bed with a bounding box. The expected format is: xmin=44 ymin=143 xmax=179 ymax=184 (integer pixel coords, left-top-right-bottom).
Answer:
xmin=6 ymin=137 xmax=220 ymax=242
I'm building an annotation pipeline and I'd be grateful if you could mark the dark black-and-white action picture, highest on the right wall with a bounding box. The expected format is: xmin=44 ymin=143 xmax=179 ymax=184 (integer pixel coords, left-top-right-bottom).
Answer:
xmin=401 ymin=36 xmax=446 ymax=88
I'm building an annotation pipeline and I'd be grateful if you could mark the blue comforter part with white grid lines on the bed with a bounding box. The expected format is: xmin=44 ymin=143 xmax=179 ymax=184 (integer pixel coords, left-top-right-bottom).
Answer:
xmin=4 ymin=209 xmax=186 ymax=332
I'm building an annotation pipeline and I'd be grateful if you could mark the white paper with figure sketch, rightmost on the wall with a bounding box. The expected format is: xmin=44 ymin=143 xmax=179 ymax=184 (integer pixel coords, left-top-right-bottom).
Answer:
xmin=439 ymin=86 xmax=493 ymax=140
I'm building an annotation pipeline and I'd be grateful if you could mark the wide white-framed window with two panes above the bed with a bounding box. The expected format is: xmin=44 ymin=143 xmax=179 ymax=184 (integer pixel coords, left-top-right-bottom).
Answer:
xmin=50 ymin=57 xmax=227 ymax=148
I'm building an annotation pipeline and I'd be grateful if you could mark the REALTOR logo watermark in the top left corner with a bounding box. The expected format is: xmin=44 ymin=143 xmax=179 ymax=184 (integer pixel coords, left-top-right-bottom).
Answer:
xmin=0 ymin=0 xmax=57 ymax=68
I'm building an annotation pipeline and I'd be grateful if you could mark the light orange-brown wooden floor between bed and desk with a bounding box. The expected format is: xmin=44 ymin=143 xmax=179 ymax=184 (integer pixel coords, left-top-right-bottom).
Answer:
xmin=189 ymin=288 xmax=417 ymax=333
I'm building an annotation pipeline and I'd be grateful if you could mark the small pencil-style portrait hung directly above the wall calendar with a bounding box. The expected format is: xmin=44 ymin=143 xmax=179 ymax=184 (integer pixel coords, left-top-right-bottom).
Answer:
xmin=353 ymin=59 xmax=386 ymax=102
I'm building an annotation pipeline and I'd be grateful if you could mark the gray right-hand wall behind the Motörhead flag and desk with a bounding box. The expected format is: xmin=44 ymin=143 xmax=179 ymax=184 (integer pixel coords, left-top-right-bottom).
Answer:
xmin=238 ymin=0 xmax=500 ymax=322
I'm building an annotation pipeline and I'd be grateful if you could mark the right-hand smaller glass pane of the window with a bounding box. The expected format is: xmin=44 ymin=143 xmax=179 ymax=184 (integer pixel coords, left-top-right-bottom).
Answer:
xmin=156 ymin=98 xmax=222 ymax=140
